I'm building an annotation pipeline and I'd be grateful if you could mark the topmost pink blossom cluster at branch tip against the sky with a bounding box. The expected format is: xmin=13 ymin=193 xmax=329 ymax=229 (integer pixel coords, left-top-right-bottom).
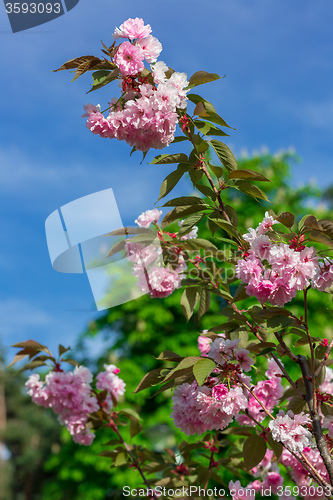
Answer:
xmin=83 ymin=18 xmax=188 ymax=152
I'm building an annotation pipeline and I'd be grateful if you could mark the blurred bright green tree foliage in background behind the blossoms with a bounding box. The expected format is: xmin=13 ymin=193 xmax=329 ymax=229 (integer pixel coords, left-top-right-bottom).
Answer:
xmin=0 ymin=153 xmax=332 ymax=500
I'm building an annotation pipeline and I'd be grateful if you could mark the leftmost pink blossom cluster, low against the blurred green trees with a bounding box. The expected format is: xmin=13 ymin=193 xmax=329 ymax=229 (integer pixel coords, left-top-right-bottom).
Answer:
xmin=25 ymin=365 xmax=125 ymax=446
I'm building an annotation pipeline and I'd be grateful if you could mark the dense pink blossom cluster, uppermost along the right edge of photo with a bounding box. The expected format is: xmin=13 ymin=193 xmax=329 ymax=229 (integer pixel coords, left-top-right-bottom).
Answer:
xmin=236 ymin=212 xmax=333 ymax=306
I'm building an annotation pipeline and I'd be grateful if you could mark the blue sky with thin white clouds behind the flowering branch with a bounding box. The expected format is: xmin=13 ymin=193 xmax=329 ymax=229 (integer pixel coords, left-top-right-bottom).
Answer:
xmin=0 ymin=0 xmax=333 ymax=360
